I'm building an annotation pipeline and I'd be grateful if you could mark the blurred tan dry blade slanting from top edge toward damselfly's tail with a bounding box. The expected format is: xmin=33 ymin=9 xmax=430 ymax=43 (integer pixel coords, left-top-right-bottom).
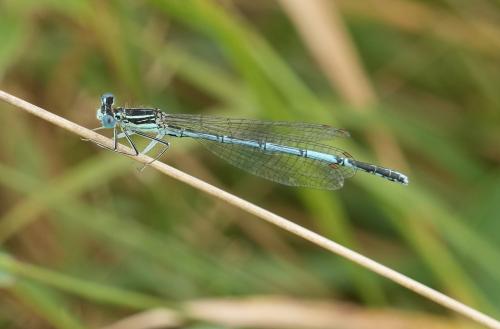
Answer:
xmin=280 ymin=0 xmax=408 ymax=171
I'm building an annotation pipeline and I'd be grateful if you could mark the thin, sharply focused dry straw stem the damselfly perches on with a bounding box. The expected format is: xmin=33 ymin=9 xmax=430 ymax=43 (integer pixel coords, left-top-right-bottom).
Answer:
xmin=0 ymin=90 xmax=500 ymax=329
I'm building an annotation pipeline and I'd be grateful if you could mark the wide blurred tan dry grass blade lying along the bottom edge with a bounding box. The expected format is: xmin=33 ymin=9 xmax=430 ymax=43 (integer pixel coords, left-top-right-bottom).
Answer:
xmin=101 ymin=296 xmax=465 ymax=329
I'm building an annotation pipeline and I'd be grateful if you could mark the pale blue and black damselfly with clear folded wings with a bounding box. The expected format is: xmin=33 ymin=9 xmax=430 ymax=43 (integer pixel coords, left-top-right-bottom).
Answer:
xmin=91 ymin=94 xmax=408 ymax=190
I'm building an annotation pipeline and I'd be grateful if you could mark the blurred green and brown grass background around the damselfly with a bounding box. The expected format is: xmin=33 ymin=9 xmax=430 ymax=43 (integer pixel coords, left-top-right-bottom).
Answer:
xmin=0 ymin=0 xmax=500 ymax=328
